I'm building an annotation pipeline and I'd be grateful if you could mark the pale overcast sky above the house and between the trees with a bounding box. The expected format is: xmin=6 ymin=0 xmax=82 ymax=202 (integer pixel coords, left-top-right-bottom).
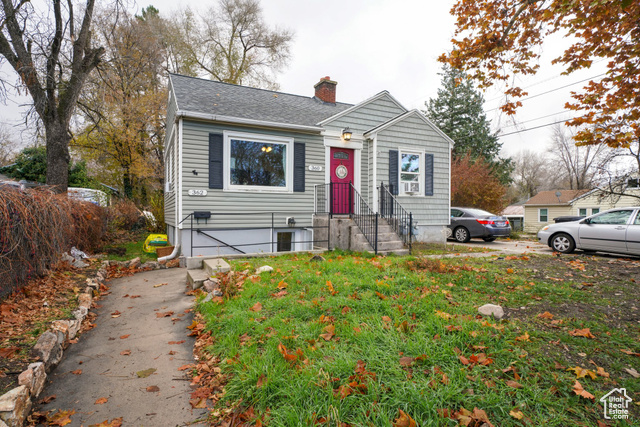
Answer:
xmin=0 ymin=0 xmax=603 ymax=156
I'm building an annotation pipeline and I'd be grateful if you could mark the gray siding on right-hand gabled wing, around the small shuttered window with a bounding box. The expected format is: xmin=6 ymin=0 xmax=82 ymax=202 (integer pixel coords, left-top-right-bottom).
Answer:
xmin=378 ymin=116 xmax=450 ymax=225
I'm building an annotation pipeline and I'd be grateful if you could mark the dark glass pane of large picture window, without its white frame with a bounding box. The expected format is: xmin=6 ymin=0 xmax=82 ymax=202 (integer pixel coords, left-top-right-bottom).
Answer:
xmin=229 ymin=138 xmax=287 ymax=188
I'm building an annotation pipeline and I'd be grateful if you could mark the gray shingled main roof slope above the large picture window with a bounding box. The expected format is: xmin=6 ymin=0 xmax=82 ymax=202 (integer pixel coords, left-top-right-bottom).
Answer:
xmin=169 ymin=74 xmax=352 ymax=126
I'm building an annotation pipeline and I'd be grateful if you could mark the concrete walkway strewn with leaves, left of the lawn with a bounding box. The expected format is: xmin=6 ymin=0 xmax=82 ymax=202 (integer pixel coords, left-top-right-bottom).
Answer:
xmin=36 ymin=268 xmax=205 ymax=426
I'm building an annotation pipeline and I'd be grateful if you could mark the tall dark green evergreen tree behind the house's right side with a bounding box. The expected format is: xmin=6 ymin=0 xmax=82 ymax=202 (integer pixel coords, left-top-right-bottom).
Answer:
xmin=425 ymin=65 xmax=513 ymax=184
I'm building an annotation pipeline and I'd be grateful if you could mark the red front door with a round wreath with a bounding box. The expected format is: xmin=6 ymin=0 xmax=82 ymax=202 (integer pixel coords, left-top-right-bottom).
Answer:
xmin=330 ymin=147 xmax=354 ymax=214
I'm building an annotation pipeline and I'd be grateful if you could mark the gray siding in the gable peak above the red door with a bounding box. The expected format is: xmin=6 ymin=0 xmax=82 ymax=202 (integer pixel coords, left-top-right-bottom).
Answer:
xmin=324 ymin=96 xmax=407 ymax=133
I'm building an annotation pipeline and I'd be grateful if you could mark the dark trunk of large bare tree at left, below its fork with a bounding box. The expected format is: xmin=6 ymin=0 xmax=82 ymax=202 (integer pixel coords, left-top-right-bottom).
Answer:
xmin=45 ymin=120 xmax=71 ymax=193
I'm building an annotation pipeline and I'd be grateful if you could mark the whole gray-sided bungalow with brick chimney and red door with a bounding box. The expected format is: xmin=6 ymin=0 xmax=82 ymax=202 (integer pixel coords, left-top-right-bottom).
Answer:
xmin=165 ymin=74 xmax=453 ymax=256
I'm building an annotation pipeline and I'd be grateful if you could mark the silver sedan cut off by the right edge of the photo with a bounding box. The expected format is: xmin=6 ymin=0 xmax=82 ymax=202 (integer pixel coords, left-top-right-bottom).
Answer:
xmin=538 ymin=207 xmax=640 ymax=255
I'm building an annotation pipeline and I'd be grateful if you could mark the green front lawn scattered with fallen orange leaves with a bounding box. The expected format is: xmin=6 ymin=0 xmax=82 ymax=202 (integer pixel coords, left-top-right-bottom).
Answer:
xmin=199 ymin=252 xmax=640 ymax=426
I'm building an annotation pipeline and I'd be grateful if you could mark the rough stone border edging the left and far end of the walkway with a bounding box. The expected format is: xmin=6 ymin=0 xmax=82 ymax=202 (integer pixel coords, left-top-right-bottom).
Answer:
xmin=0 ymin=258 xmax=178 ymax=427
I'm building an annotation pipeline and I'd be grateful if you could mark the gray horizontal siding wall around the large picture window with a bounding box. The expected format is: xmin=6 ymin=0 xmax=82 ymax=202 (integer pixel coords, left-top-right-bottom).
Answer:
xmin=182 ymin=119 xmax=325 ymax=228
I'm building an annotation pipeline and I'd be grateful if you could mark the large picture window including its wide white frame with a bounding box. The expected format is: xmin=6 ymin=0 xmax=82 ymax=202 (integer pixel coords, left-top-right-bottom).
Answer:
xmin=224 ymin=133 xmax=293 ymax=192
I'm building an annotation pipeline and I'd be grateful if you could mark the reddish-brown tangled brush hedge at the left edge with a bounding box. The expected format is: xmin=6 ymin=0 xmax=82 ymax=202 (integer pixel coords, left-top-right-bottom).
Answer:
xmin=0 ymin=189 xmax=105 ymax=298
